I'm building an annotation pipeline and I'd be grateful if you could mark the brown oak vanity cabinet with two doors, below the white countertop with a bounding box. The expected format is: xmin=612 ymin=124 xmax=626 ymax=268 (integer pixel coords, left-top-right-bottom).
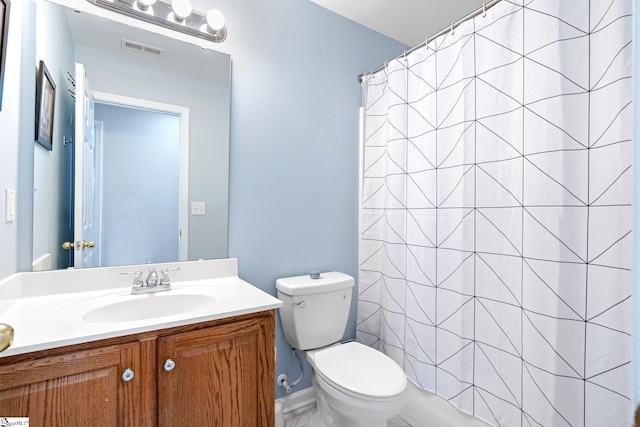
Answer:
xmin=0 ymin=310 xmax=275 ymax=427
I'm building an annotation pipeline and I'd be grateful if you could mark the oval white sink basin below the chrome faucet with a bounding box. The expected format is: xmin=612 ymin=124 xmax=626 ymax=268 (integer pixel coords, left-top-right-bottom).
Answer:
xmin=82 ymin=291 xmax=216 ymax=323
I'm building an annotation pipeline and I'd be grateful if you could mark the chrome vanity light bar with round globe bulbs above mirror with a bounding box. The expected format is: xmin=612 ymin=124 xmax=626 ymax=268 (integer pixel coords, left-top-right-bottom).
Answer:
xmin=87 ymin=0 xmax=227 ymax=43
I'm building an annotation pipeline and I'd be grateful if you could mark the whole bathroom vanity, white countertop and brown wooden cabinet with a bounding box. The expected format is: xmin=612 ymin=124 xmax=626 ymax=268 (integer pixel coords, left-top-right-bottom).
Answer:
xmin=0 ymin=260 xmax=282 ymax=426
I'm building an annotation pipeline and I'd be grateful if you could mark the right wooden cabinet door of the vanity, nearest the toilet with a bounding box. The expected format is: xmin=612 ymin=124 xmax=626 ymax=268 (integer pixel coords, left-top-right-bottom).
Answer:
xmin=158 ymin=312 xmax=275 ymax=427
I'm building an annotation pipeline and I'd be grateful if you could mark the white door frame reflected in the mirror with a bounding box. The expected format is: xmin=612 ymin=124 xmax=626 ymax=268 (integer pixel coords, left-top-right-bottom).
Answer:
xmin=93 ymin=91 xmax=189 ymax=261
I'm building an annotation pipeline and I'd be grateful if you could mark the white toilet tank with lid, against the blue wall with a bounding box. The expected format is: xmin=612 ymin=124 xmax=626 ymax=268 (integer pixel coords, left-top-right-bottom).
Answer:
xmin=276 ymin=271 xmax=355 ymax=350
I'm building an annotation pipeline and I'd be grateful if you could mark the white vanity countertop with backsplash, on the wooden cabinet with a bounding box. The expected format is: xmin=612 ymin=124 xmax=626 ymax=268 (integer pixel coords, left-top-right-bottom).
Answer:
xmin=0 ymin=259 xmax=282 ymax=358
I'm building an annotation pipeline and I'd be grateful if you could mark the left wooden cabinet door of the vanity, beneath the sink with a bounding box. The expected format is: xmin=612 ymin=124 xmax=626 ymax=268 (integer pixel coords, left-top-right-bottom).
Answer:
xmin=0 ymin=343 xmax=140 ymax=427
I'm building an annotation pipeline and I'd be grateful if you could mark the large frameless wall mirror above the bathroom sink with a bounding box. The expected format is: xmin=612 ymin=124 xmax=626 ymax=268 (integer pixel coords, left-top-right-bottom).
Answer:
xmin=33 ymin=0 xmax=231 ymax=271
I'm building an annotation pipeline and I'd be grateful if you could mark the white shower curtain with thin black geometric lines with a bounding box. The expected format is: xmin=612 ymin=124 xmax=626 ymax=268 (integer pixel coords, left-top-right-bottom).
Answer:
xmin=357 ymin=0 xmax=632 ymax=427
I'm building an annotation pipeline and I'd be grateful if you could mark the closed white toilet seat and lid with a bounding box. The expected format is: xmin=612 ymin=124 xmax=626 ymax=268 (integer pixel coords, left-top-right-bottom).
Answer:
xmin=313 ymin=342 xmax=407 ymax=400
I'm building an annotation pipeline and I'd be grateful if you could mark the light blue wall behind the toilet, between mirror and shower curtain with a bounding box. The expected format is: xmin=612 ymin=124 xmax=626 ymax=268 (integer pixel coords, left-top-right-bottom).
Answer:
xmin=216 ymin=0 xmax=406 ymax=396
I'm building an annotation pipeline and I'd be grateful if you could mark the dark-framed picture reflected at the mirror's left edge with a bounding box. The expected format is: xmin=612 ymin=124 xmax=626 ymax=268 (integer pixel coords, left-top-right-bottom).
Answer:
xmin=36 ymin=61 xmax=56 ymax=150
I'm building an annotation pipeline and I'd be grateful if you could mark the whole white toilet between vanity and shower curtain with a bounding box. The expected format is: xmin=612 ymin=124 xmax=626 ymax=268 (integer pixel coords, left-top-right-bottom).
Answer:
xmin=276 ymin=272 xmax=407 ymax=427
